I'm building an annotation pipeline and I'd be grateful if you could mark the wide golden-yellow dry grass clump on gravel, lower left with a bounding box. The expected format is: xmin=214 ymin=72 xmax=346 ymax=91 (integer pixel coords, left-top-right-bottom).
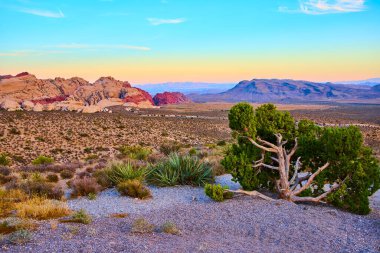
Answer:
xmin=16 ymin=197 xmax=71 ymax=220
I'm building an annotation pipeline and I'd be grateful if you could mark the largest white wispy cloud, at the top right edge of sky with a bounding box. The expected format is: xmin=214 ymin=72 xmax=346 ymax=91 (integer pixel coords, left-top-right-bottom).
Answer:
xmin=278 ymin=0 xmax=366 ymax=15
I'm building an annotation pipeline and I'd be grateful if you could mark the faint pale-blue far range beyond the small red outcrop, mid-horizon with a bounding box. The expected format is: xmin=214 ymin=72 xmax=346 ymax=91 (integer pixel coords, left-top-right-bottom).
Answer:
xmin=135 ymin=82 xmax=235 ymax=96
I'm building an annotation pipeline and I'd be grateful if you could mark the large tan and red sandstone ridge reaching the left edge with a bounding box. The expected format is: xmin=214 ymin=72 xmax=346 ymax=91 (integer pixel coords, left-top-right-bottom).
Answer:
xmin=0 ymin=72 xmax=154 ymax=112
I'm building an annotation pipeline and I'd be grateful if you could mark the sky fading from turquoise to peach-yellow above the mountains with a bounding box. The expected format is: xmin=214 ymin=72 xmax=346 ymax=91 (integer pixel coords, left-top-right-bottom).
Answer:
xmin=0 ymin=0 xmax=380 ymax=84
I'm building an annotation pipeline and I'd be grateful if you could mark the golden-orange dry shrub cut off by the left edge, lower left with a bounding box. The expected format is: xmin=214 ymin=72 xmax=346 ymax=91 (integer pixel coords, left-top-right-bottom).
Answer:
xmin=0 ymin=188 xmax=28 ymax=217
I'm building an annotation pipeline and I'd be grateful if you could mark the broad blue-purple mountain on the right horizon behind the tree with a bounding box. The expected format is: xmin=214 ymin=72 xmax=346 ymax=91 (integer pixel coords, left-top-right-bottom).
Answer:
xmin=189 ymin=79 xmax=380 ymax=104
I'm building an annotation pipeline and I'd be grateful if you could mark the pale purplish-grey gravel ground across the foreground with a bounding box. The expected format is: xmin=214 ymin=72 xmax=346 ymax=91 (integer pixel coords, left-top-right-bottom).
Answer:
xmin=2 ymin=176 xmax=380 ymax=253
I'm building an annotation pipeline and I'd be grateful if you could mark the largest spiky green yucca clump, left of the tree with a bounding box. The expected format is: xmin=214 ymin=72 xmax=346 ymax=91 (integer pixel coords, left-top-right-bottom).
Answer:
xmin=146 ymin=153 xmax=213 ymax=186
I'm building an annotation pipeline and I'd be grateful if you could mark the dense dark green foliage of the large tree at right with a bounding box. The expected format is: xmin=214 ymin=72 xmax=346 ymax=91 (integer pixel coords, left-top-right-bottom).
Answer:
xmin=222 ymin=103 xmax=380 ymax=214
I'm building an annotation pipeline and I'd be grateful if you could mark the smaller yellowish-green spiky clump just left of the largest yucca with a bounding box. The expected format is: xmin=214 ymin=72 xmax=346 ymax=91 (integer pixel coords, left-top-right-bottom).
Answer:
xmin=107 ymin=162 xmax=146 ymax=186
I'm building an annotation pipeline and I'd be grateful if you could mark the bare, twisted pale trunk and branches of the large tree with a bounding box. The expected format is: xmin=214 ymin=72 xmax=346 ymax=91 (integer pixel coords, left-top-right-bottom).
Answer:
xmin=247 ymin=134 xmax=340 ymax=202
